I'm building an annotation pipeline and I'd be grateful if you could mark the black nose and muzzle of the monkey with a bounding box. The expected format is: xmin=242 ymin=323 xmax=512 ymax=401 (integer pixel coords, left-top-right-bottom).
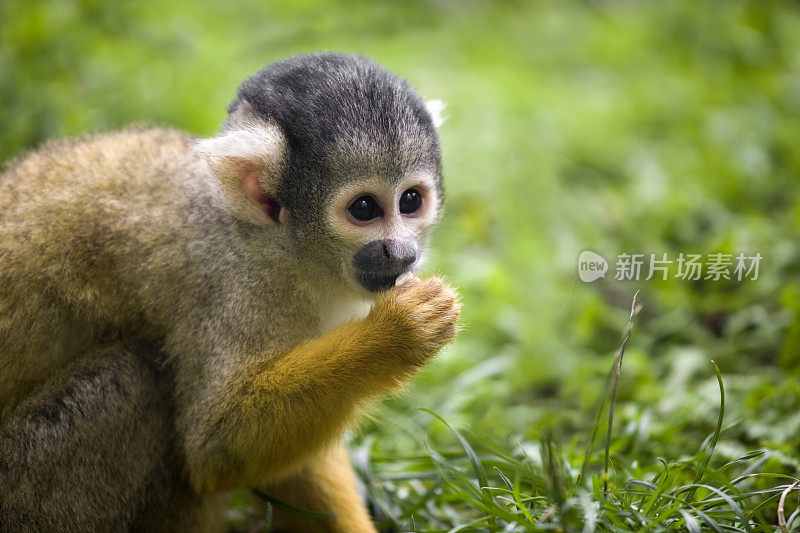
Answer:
xmin=353 ymin=239 xmax=417 ymax=292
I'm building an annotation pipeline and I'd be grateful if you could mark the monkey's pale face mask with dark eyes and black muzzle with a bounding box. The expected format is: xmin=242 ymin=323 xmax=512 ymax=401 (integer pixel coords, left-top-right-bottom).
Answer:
xmin=328 ymin=171 xmax=441 ymax=292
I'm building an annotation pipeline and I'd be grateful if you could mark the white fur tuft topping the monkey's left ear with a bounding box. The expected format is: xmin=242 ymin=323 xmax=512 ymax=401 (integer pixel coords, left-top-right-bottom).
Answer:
xmin=194 ymin=124 xmax=284 ymax=163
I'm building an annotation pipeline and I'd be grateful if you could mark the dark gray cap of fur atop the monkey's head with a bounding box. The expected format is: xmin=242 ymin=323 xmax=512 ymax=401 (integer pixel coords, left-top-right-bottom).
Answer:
xmin=228 ymin=53 xmax=441 ymax=219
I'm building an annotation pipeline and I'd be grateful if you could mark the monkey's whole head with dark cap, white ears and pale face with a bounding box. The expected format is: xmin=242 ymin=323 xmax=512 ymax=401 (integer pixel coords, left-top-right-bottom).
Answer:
xmin=196 ymin=53 xmax=443 ymax=292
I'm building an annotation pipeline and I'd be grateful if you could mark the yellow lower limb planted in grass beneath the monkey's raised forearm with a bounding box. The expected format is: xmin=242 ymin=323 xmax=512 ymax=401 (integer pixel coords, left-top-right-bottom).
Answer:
xmin=264 ymin=445 xmax=375 ymax=533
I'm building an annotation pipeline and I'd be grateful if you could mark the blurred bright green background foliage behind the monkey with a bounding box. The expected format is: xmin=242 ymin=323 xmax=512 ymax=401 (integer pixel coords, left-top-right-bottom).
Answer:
xmin=0 ymin=0 xmax=800 ymax=524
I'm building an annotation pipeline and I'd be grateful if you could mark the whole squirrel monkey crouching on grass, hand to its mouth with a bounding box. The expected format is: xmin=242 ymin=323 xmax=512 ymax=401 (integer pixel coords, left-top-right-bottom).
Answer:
xmin=0 ymin=53 xmax=459 ymax=532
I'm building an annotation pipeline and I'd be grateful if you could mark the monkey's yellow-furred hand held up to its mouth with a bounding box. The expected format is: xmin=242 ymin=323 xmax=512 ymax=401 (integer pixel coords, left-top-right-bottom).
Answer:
xmin=366 ymin=277 xmax=461 ymax=366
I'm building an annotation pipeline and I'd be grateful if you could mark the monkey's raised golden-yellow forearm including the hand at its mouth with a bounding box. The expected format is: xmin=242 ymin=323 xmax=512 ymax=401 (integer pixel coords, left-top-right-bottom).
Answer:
xmin=184 ymin=278 xmax=459 ymax=491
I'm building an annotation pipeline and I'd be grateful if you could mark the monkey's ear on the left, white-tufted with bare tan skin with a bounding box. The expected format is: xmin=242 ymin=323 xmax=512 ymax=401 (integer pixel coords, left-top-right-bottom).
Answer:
xmin=194 ymin=124 xmax=289 ymax=226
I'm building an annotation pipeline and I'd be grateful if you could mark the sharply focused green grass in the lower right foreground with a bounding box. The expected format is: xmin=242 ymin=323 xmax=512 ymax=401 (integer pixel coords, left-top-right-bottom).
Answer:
xmin=357 ymin=297 xmax=800 ymax=533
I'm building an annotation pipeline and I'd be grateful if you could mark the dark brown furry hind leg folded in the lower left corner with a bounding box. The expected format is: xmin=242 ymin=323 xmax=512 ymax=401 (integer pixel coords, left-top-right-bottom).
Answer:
xmin=0 ymin=346 xmax=217 ymax=531
